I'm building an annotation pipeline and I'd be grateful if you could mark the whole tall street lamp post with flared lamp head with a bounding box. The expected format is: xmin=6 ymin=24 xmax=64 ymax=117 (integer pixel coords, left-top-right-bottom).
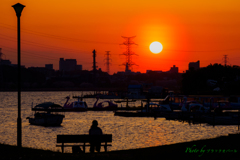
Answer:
xmin=12 ymin=3 xmax=25 ymax=147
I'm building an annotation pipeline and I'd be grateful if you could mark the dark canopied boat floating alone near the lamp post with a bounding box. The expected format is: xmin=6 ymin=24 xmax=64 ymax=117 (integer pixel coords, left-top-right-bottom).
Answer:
xmin=26 ymin=102 xmax=65 ymax=126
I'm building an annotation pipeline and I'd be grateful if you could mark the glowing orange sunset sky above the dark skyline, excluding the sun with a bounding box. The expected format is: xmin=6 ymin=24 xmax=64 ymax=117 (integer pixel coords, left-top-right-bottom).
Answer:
xmin=0 ymin=0 xmax=240 ymax=74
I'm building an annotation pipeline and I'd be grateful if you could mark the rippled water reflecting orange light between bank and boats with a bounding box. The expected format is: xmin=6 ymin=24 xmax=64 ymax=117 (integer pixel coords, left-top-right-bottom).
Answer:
xmin=0 ymin=91 xmax=238 ymax=152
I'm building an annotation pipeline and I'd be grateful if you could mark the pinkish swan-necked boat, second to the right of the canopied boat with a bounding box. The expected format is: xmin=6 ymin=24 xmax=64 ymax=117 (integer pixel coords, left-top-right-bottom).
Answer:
xmin=93 ymin=97 xmax=118 ymax=111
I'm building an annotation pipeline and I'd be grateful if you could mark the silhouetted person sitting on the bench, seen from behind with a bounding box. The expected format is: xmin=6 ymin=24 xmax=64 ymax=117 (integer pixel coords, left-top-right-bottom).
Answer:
xmin=89 ymin=120 xmax=103 ymax=153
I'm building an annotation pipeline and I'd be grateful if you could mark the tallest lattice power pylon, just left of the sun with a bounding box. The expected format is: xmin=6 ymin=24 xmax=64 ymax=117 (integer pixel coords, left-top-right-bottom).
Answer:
xmin=121 ymin=36 xmax=137 ymax=71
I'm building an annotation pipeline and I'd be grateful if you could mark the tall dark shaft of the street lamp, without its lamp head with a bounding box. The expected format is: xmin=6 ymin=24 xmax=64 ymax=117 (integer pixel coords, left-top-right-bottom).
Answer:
xmin=17 ymin=16 xmax=22 ymax=147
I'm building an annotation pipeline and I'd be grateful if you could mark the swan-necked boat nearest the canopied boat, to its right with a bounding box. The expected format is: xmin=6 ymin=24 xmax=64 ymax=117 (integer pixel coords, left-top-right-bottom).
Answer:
xmin=63 ymin=96 xmax=88 ymax=112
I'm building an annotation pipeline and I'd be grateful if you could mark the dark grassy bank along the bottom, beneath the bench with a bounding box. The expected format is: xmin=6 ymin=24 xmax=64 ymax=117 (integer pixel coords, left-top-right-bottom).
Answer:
xmin=0 ymin=134 xmax=240 ymax=160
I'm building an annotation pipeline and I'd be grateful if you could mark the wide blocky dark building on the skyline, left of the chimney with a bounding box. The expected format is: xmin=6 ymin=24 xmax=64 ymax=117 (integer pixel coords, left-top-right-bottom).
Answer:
xmin=59 ymin=58 xmax=82 ymax=71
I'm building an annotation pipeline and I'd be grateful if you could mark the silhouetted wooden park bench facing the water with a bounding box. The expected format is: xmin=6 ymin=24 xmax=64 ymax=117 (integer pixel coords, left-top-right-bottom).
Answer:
xmin=56 ymin=134 xmax=112 ymax=153
